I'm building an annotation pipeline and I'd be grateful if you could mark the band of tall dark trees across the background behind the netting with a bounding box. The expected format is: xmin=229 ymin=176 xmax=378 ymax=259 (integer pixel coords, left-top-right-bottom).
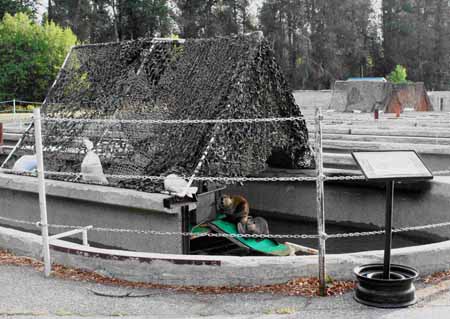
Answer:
xmin=0 ymin=0 xmax=450 ymax=99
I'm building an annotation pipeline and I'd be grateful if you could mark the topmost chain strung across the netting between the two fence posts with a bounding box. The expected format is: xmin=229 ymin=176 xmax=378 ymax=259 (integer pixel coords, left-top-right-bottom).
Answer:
xmin=41 ymin=116 xmax=304 ymax=124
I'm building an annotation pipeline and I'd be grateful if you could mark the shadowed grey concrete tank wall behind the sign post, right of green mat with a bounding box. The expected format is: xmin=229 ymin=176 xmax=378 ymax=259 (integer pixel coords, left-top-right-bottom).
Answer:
xmin=230 ymin=177 xmax=450 ymax=238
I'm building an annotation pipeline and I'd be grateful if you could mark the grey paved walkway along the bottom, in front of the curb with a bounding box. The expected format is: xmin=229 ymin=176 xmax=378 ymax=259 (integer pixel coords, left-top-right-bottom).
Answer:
xmin=0 ymin=266 xmax=450 ymax=319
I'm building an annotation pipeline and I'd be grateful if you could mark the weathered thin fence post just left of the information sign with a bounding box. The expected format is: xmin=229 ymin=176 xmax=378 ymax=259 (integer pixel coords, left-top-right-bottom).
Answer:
xmin=315 ymin=108 xmax=326 ymax=296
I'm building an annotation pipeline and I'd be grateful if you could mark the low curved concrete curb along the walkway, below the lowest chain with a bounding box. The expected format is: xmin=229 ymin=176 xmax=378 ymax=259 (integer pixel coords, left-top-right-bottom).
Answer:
xmin=0 ymin=227 xmax=450 ymax=286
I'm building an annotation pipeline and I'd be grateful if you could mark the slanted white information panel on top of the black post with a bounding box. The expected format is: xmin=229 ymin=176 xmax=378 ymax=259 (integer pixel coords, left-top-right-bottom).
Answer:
xmin=352 ymin=151 xmax=433 ymax=180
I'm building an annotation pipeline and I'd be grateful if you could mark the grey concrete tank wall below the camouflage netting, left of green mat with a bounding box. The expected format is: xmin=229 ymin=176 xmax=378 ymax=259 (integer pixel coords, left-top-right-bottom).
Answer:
xmin=0 ymin=174 xmax=186 ymax=254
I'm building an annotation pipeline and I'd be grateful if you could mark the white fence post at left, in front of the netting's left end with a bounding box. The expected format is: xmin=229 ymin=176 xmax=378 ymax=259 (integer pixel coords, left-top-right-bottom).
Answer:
xmin=33 ymin=108 xmax=51 ymax=277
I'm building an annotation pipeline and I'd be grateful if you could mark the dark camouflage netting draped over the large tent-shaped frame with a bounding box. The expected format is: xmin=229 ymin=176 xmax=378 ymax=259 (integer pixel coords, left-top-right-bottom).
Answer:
xmin=13 ymin=34 xmax=314 ymax=192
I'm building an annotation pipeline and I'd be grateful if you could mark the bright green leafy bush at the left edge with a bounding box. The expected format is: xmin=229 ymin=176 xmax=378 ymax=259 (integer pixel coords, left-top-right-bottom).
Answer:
xmin=0 ymin=13 xmax=77 ymax=101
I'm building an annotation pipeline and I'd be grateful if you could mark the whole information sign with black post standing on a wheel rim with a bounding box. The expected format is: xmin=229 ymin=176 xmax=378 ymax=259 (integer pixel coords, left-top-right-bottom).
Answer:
xmin=352 ymin=151 xmax=433 ymax=308
